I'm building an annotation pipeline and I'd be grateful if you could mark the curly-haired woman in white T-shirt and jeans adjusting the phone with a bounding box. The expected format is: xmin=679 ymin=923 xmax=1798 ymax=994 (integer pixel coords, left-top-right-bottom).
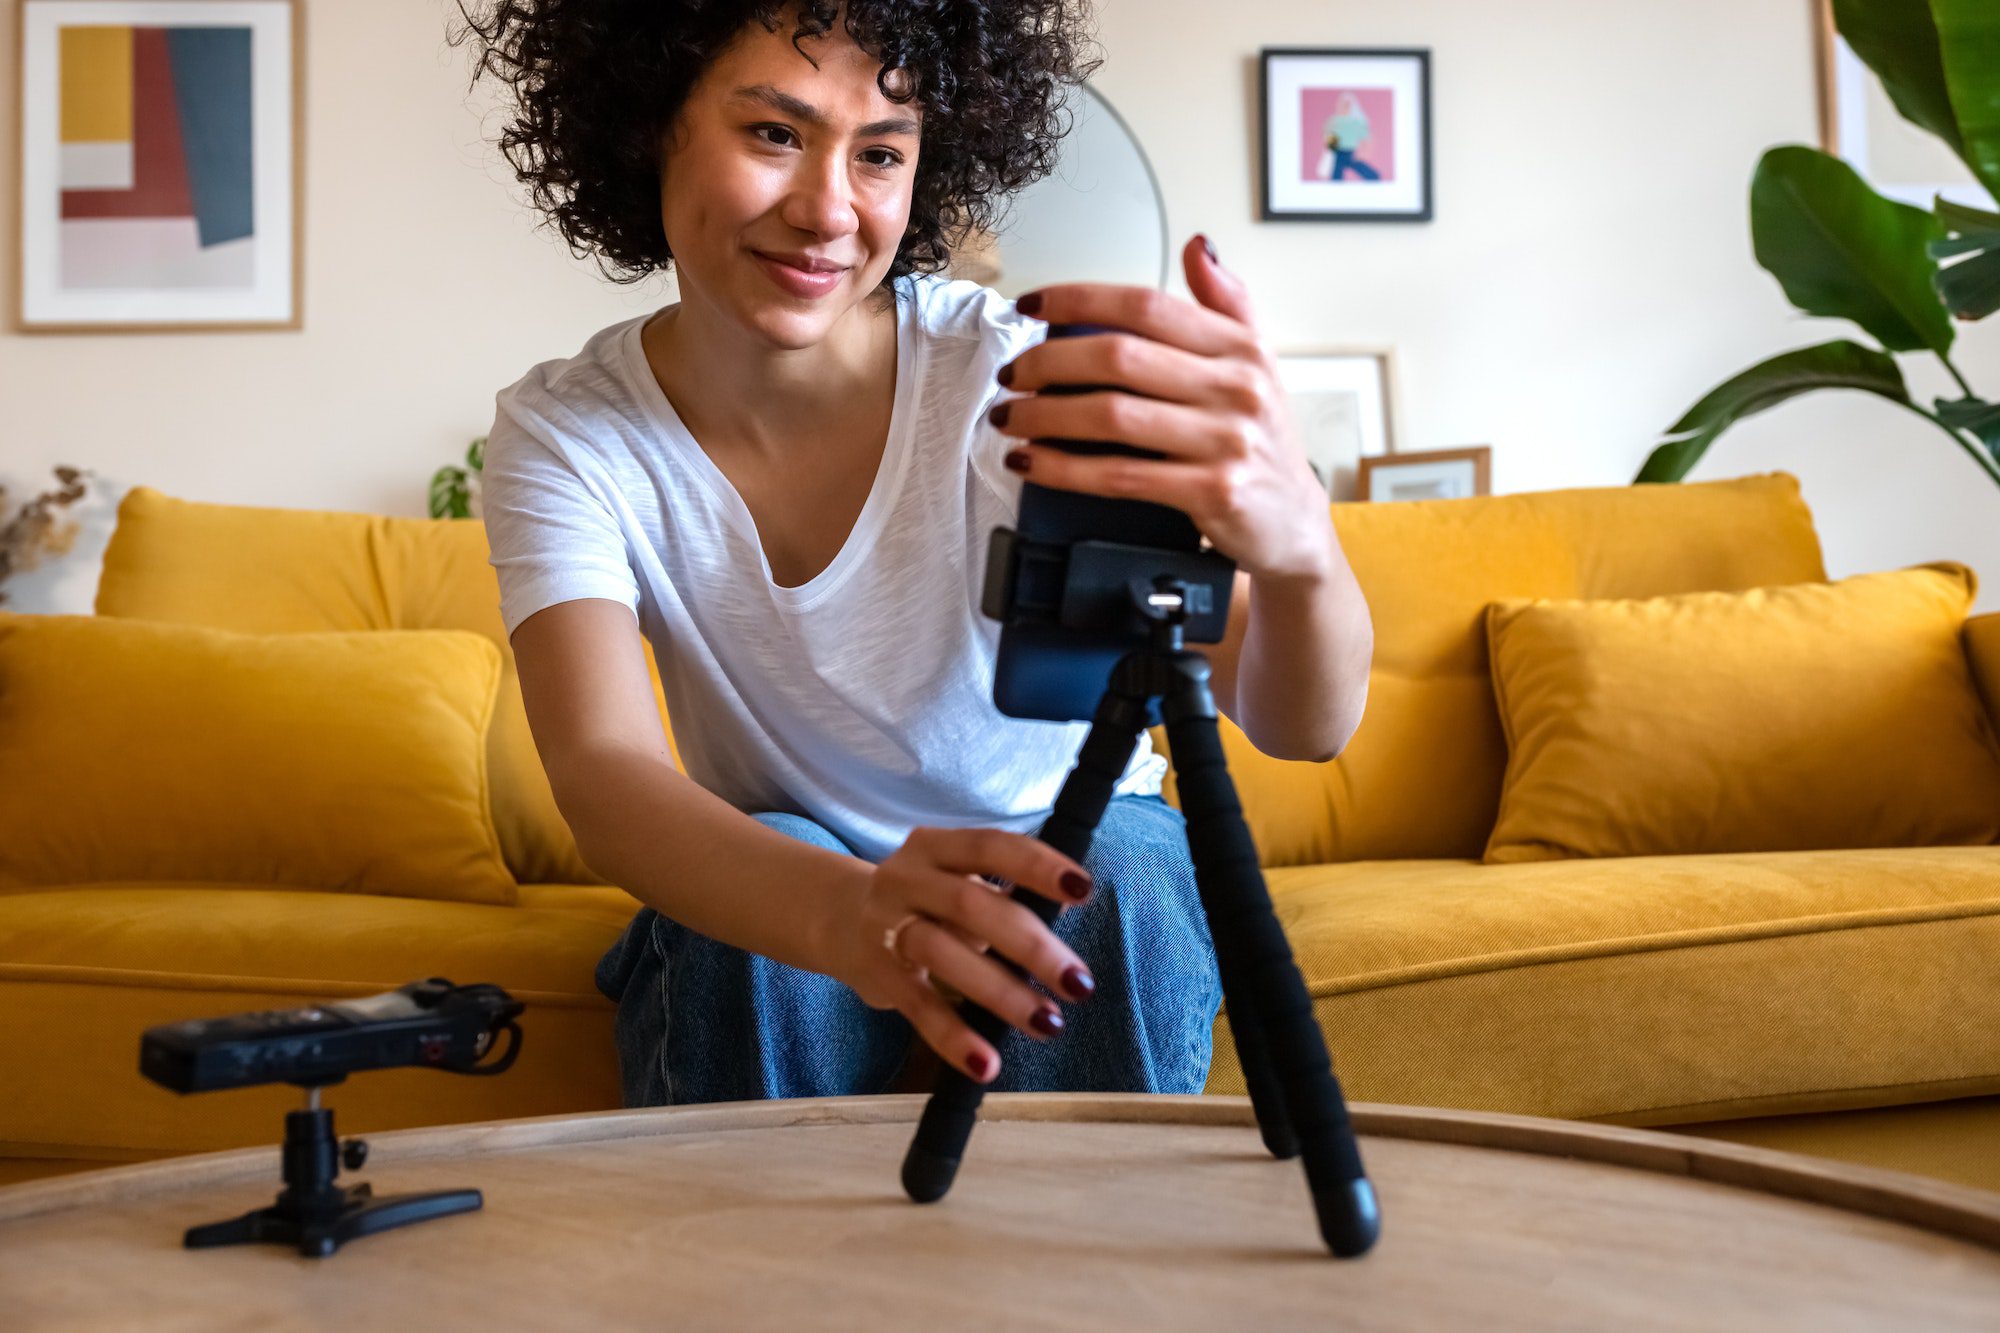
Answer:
xmin=450 ymin=0 xmax=1372 ymax=1105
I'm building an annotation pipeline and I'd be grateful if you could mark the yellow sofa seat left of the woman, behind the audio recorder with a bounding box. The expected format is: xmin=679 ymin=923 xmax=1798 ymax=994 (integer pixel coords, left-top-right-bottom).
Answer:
xmin=0 ymin=883 xmax=630 ymax=1157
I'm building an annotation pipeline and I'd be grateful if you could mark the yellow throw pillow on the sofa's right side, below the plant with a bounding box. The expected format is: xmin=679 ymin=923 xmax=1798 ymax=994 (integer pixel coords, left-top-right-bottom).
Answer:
xmin=1484 ymin=560 xmax=2000 ymax=863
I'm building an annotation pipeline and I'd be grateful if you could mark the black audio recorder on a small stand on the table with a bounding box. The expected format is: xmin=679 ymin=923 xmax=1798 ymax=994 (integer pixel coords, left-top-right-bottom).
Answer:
xmin=140 ymin=977 xmax=524 ymax=1259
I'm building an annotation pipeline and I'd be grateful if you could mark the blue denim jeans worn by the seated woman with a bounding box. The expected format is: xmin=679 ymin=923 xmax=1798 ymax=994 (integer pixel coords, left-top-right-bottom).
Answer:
xmin=596 ymin=797 xmax=1222 ymax=1107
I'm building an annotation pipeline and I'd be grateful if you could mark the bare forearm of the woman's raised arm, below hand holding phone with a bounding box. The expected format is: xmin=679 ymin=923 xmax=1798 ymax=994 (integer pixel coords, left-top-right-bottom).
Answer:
xmin=1236 ymin=540 xmax=1374 ymax=763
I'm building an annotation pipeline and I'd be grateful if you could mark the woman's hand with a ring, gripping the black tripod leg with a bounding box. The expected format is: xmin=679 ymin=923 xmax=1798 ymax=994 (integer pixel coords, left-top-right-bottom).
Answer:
xmin=834 ymin=827 xmax=1096 ymax=1083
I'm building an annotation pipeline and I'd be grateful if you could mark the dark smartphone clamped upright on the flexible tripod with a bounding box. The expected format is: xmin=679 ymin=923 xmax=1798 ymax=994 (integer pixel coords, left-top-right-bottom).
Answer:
xmin=986 ymin=324 xmax=1228 ymax=727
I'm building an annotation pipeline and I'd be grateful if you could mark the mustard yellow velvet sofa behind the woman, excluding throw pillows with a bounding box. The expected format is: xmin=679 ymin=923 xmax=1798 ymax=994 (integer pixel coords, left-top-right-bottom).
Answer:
xmin=0 ymin=472 xmax=2000 ymax=1189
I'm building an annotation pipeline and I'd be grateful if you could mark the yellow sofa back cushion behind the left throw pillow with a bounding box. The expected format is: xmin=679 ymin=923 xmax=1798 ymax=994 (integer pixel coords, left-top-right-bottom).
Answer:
xmin=96 ymin=486 xmax=674 ymax=885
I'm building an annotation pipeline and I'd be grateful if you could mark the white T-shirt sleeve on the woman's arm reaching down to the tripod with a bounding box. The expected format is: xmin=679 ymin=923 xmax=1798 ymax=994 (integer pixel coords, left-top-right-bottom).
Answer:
xmin=480 ymin=402 xmax=640 ymax=636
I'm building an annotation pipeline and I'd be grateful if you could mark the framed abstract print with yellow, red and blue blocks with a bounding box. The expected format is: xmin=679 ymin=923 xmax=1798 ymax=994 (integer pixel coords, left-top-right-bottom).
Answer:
xmin=14 ymin=0 xmax=304 ymax=332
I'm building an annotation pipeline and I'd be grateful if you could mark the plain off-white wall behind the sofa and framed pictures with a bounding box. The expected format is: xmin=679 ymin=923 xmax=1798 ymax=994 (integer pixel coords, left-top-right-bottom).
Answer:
xmin=0 ymin=0 xmax=2000 ymax=612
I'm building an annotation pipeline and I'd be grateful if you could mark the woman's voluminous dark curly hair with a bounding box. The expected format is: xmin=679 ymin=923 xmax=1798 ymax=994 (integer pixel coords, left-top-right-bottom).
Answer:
xmin=446 ymin=0 xmax=1104 ymax=286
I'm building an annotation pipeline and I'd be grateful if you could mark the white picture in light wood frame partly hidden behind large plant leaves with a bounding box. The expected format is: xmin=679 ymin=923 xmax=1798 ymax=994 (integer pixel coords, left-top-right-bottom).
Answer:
xmin=1812 ymin=0 xmax=1992 ymax=212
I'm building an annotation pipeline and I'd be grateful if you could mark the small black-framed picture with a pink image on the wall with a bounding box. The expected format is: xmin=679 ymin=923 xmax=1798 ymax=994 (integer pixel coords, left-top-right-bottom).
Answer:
xmin=1258 ymin=46 xmax=1432 ymax=222
